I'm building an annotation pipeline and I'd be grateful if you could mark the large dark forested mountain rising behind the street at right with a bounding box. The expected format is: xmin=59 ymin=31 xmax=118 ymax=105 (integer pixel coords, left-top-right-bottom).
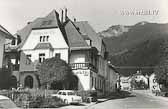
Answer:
xmin=103 ymin=22 xmax=168 ymax=76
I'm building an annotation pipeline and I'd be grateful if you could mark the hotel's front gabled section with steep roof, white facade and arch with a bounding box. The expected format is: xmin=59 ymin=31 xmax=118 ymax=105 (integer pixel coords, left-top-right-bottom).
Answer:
xmin=19 ymin=10 xmax=69 ymax=88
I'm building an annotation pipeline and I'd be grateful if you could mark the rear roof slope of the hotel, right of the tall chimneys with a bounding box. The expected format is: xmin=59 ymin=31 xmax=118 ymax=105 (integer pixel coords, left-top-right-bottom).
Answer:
xmin=74 ymin=21 xmax=102 ymax=52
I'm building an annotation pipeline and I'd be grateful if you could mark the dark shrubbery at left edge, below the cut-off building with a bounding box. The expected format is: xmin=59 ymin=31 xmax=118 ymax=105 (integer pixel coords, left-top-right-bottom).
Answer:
xmin=0 ymin=68 xmax=11 ymax=89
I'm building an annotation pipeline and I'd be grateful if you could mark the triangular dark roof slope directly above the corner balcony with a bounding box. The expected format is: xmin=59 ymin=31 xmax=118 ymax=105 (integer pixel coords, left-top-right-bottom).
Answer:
xmin=64 ymin=19 xmax=90 ymax=50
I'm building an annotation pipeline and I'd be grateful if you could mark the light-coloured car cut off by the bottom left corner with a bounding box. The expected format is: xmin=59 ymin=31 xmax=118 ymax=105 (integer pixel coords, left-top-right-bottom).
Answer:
xmin=0 ymin=95 xmax=18 ymax=109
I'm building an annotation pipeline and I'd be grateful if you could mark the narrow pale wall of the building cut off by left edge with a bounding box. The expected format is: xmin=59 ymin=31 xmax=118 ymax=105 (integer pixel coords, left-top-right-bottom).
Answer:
xmin=0 ymin=34 xmax=5 ymax=68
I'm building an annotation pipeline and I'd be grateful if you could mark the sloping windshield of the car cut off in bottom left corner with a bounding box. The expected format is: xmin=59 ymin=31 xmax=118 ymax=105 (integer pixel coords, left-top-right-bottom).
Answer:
xmin=0 ymin=99 xmax=17 ymax=109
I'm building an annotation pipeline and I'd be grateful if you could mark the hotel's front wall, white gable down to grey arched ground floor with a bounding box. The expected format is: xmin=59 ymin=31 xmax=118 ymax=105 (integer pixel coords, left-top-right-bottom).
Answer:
xmin=19 ymin=28 xmax=69 ymax=88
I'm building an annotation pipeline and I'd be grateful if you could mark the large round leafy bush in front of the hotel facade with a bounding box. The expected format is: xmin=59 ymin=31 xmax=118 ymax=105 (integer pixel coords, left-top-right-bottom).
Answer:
xmin=37 ymin=57 xmax=77 ymax=89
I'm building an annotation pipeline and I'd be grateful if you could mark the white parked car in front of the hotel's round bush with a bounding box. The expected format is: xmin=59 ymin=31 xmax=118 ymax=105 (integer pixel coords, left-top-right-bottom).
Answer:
xmin=51 ymin=90 xmax=82 ymax=104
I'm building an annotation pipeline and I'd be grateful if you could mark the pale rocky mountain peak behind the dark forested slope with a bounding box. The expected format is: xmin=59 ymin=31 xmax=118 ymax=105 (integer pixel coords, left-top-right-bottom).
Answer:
xmin=98 ymin=25 xmax=131 ymax=37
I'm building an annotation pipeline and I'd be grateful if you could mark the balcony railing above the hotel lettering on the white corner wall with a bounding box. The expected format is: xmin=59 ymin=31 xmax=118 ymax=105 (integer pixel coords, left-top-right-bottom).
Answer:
xmin=70 ymin=63 xmax=98 ymax=73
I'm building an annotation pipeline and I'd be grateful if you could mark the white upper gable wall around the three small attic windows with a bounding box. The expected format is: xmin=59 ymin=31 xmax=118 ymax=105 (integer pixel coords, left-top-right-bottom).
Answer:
xmin=21 ymin=28 xmax=68 ymax=50
